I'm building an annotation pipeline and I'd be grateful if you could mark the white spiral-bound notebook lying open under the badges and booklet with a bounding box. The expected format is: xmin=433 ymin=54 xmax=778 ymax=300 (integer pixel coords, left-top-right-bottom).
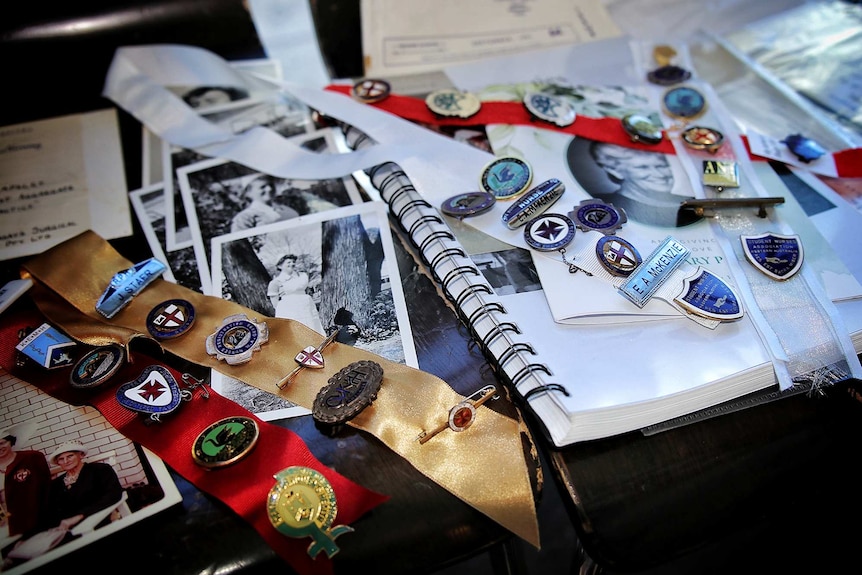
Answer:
xmin=342 ymin=125 xmax=862 ymax=447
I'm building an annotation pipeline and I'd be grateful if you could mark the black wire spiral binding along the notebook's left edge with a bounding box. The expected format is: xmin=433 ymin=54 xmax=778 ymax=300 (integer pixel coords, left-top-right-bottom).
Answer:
xmin=339 ymin=123 xmax=569 ymax=412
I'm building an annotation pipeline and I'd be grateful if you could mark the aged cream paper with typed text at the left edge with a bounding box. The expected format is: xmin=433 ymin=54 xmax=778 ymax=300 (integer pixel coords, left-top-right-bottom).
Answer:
xmin=0 ymin=109 xmax=132 ymax=259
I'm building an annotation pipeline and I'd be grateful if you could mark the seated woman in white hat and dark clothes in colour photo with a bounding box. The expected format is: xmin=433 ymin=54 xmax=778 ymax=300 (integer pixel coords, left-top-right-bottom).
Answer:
xmin=50 ymin=441 xmax=123 ymax=529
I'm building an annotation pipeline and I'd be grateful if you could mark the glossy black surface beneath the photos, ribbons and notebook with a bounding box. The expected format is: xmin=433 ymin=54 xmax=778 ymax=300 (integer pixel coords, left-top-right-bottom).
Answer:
xmin=5 ymin=0 xmax=862 ymax=573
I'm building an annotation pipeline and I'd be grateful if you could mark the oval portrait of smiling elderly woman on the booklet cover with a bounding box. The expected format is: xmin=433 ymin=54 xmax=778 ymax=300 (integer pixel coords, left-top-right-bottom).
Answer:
xmin=566 ymin=137 xmax=701 ymax=228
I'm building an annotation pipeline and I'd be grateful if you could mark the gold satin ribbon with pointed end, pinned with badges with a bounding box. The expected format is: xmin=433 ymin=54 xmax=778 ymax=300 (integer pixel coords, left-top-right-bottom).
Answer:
xmin=21 ymin=231 xmax=539 ymax=548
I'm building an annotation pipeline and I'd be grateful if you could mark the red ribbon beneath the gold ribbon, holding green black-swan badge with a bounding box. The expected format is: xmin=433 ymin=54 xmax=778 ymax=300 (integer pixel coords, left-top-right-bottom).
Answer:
xmin=0 ymin=302 xmax=389 ymax=575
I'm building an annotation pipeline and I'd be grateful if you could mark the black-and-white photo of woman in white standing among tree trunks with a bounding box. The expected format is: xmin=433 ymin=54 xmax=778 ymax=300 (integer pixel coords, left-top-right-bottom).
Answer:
xmin=206 ymin=202 xmax=418 ymax=418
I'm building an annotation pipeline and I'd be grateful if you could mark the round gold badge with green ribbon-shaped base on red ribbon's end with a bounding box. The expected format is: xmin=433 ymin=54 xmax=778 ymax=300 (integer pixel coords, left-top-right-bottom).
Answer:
xmin=267 ymin=466 xmax=353 ymax=559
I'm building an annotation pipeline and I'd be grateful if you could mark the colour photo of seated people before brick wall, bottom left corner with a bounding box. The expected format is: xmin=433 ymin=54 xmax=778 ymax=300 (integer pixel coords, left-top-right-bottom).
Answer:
xmin=0 ymin=371 xmax=182 ymax=575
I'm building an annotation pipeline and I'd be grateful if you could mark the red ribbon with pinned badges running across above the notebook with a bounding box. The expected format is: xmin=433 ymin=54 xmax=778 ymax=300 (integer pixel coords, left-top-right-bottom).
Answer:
xmin=326 ymin=84 xmax=862 ymax=178
